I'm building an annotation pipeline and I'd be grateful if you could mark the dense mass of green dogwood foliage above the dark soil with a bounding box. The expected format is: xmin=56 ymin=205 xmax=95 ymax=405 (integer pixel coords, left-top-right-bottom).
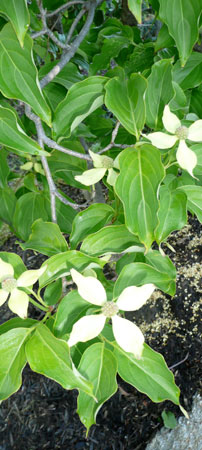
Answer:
xmin=0 ymin=0 xmax=202 ymax=429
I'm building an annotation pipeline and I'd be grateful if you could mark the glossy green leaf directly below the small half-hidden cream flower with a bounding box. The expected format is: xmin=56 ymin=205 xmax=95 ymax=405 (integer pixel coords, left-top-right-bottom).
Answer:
xmin=70 ymin=203 xmax=115 ymax=248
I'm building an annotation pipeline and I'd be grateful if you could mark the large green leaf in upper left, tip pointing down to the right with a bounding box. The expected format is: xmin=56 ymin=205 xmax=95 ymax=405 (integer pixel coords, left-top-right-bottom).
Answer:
xmin=0 ymin=23 xmax=51 ymax=126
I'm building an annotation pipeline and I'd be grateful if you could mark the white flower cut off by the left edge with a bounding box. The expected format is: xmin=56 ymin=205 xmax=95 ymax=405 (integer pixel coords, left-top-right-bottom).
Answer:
xmin=0 ymin=258 xmax=46 ymax=319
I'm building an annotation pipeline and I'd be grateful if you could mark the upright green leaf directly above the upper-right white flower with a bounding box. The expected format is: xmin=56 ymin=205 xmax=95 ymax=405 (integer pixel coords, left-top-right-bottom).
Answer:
xmin=145 ymin=59 xmax=175 ymax=129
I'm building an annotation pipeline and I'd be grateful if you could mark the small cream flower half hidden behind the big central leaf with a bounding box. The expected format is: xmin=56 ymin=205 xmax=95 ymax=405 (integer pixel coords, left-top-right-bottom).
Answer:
xmin=75 ymin=150 xmax=118 ymax=186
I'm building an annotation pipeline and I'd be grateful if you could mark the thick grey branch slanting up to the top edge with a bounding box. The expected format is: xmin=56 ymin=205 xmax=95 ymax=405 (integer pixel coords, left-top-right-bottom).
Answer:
xmin=40 ymin=0 xmax=98 ymax=88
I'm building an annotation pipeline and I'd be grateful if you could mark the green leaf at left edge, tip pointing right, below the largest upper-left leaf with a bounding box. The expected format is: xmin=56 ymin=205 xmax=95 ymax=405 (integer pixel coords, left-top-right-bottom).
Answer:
xmin=0 ymin=107 xmax=48 ymax=156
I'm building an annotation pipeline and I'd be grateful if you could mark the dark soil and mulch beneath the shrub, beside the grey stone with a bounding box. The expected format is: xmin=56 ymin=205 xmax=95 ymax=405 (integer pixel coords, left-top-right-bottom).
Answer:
xmin=0 ymin=218 xmax=202 ymax=450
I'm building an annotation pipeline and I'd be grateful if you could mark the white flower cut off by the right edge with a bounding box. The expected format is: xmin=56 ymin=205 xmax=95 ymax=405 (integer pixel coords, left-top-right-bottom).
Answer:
xmin=147 ymin=105 xmax=202 ymax=177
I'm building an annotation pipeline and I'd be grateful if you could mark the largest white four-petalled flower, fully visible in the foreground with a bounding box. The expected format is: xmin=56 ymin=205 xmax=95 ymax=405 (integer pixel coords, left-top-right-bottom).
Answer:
xmin=68 ymin=269 xmax=155 ymax=359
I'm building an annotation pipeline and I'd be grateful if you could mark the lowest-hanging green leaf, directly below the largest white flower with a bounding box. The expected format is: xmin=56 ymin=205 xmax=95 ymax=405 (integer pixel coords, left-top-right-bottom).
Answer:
xmin=77 ymin=343 xmax=118 ymax=432
